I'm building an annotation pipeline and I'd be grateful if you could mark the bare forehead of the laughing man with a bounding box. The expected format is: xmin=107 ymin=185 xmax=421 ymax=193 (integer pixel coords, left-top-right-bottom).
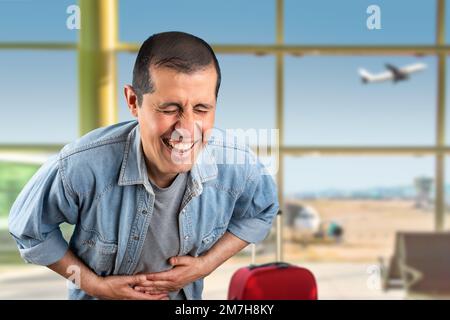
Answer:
xmin=150 ymin=65 xmax=217 ymax=100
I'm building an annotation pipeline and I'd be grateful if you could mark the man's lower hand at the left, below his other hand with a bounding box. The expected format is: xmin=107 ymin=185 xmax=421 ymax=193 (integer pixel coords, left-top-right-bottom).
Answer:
xmin=92 ymin=274 xmax=168 ymax=300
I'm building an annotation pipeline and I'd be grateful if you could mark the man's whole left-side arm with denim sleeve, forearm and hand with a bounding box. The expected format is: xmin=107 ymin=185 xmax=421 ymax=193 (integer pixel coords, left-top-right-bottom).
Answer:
xmin=8 ymin=157 xmax=167 ymax=299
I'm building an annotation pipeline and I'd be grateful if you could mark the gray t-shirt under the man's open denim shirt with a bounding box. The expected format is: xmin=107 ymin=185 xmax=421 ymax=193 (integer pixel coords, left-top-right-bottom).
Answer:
xmin=135 ymin=173 xmax=188 ymax=300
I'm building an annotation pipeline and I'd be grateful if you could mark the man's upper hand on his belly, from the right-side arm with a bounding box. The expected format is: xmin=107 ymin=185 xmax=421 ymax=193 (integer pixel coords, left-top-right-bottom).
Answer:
xmin=134 ymin=256 xmax=213 ymax=294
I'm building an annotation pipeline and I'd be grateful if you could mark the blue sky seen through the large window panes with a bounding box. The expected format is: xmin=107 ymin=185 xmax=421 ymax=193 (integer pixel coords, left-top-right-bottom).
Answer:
xmin=0 ymin=0 xmax=450 ymax=192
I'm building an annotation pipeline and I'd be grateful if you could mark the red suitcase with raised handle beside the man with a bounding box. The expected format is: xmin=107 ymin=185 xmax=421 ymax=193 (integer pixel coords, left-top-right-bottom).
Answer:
xmin=228 ymin=211 xmax=317 ymax=300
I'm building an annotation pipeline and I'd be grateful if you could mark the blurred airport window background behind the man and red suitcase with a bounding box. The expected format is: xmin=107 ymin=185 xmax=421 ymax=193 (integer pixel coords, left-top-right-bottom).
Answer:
xmin=0 ymin=0 xmax=450 ymax=299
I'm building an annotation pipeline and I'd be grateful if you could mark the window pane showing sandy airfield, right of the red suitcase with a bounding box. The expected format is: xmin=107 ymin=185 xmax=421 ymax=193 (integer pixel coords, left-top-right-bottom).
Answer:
xmin=284 ymin=156 xmax=434 ymax=299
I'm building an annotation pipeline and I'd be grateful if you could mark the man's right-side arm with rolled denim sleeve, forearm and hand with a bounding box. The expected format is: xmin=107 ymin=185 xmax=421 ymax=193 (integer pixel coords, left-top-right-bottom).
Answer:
xmin=136 ymin=155 xmax=279 ymax=291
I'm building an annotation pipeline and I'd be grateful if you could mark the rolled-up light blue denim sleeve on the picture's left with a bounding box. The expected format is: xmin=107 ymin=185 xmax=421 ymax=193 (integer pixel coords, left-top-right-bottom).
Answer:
xmin=8 ymin=156 xmax=78 ymax=266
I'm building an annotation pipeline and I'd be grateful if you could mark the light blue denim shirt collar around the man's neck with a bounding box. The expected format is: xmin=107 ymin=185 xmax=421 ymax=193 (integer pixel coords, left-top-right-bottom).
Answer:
xmin=118 ymin=124 xmax=217 ymax=190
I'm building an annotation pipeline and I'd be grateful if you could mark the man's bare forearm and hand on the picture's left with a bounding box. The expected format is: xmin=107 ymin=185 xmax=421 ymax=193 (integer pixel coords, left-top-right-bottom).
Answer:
xmin=48 ymin=250 xmax=167 ymax=300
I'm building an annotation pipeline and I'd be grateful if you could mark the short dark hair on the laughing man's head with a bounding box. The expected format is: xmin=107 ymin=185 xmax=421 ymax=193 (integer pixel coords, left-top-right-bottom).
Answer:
xmin=133 ymin=31 xmax=221 ymax=106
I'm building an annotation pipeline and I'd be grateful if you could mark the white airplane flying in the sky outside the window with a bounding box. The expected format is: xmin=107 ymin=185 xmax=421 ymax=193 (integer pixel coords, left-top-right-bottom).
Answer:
xmin=358 ymin=63 xmax=427 ymax=83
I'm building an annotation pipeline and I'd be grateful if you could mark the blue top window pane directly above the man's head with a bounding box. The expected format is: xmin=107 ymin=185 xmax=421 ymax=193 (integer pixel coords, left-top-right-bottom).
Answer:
xmin=119 ymin=0 xmax=275 ymax=43
